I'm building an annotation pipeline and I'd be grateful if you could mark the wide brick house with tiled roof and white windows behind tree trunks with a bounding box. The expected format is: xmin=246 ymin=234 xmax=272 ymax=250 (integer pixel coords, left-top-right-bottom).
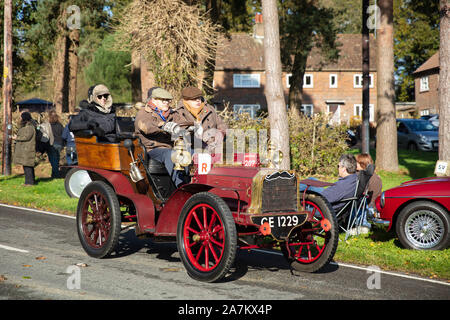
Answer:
xmin=213 ymin=24 xmax=377 ymax=123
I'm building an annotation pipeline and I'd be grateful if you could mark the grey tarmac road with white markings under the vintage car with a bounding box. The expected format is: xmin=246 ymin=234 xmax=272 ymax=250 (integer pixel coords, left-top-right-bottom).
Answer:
xmin=0 ymin=205 xmax=450 ymax=301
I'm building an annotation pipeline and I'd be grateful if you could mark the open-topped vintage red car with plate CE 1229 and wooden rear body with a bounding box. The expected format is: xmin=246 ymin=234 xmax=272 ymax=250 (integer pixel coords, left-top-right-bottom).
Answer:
xmin=68 ymin=123 xmax=339 ymax=282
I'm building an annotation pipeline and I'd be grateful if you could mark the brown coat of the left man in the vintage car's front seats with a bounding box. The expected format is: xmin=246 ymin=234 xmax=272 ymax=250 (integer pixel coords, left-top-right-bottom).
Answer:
xmin=134 ymin=106 xmax=173 ymax=152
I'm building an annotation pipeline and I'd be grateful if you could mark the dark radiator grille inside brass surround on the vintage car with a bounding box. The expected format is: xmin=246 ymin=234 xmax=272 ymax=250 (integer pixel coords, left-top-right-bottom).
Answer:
xmin=261 ymin=171 xmax=297 ymax=213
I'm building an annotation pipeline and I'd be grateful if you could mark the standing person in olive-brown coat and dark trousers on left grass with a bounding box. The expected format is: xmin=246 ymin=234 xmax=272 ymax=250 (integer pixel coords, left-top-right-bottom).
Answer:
xmin=12 ymin=112 xmax=36 ymax=186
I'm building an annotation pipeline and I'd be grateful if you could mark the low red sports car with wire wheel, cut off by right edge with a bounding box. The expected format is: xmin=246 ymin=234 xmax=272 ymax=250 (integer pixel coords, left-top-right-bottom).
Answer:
xmin=373 ymin=177 xmax=450 ymax=250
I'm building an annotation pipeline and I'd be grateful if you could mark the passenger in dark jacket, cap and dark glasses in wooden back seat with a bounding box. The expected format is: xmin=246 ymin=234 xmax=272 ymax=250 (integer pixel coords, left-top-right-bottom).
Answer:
xmin=69 ymin=84 xmax=116 ymax=142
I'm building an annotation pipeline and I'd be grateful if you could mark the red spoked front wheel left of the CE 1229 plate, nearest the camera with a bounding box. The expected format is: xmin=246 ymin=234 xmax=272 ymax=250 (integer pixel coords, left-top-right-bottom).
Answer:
xmin=177 ymin=192 xmax=236 ymax=282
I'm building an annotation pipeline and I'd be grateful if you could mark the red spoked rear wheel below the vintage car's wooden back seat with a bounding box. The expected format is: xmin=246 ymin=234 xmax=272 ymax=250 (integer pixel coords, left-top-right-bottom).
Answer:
xmin=77 ymin=181 xmax=121 ymax=258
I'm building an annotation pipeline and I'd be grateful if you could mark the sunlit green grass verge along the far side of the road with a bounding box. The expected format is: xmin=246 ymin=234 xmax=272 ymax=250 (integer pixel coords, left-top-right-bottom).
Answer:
xmin=0 ymin=149 xmax=450 ymax=282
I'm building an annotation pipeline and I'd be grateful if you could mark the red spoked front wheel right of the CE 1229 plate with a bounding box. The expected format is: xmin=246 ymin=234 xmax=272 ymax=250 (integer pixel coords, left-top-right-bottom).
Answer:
xmin=281 ymin=194 xmax=339 ymax=272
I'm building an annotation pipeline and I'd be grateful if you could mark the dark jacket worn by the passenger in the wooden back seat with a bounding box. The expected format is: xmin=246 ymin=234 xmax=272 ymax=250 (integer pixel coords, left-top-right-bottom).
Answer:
xmin=69 ymin=100 xmax=116 ymax=142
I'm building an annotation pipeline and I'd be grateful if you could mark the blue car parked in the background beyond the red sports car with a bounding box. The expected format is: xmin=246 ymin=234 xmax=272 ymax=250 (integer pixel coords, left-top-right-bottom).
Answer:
xmin=397 ymin=119 xmax=439 ymax=151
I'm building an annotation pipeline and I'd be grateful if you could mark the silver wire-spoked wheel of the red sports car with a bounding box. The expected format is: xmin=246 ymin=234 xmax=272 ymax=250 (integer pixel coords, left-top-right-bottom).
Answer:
xmin=396 ymin=201 xmax=450 ymax=250
